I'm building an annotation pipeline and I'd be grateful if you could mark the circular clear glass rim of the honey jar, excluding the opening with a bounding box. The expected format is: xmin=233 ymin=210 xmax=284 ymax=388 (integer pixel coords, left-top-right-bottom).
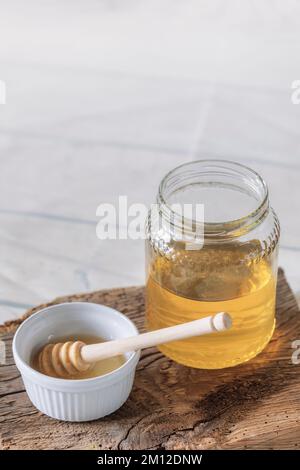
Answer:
xmin=157 ymin=159 xmax=269 ymax=238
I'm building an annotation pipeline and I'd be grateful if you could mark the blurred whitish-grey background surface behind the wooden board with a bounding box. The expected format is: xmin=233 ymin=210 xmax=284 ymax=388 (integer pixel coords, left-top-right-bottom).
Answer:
xmin=0 ymin=0 xmax=300 ymax=322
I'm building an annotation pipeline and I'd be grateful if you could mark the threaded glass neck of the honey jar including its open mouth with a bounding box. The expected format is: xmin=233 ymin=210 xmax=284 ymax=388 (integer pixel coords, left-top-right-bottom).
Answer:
xmin=157 ymin=160 xmax=270 ymax=243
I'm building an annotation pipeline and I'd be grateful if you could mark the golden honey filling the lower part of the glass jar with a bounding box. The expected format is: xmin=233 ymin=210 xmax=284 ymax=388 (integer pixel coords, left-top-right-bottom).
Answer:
xmin=146 ymin=242 xmax=276 ymax=369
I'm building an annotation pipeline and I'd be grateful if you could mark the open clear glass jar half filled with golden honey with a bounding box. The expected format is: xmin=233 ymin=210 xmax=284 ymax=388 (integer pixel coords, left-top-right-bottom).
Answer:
xmin=146 ymin=160 xmax=280 ymax=369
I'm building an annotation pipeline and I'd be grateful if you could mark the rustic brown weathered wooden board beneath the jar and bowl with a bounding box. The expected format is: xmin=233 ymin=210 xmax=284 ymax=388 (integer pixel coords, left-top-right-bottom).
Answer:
xmin=0 ymin=271 xmax=300 ymax=450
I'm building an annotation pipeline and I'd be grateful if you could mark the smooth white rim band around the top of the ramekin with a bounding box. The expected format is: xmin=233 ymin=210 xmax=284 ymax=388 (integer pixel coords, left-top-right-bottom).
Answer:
xmin=12 ymin=301 xmax=140 ymax=392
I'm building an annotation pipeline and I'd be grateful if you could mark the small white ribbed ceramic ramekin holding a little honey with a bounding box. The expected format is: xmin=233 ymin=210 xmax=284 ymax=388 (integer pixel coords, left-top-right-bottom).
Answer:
xmin=13 ymin=302 xmax=140 ymax=421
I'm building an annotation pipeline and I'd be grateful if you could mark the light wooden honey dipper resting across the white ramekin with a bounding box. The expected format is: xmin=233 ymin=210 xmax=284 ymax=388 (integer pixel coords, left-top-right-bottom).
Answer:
xmin=38 ymin=312 xmax=232 ymax=378
